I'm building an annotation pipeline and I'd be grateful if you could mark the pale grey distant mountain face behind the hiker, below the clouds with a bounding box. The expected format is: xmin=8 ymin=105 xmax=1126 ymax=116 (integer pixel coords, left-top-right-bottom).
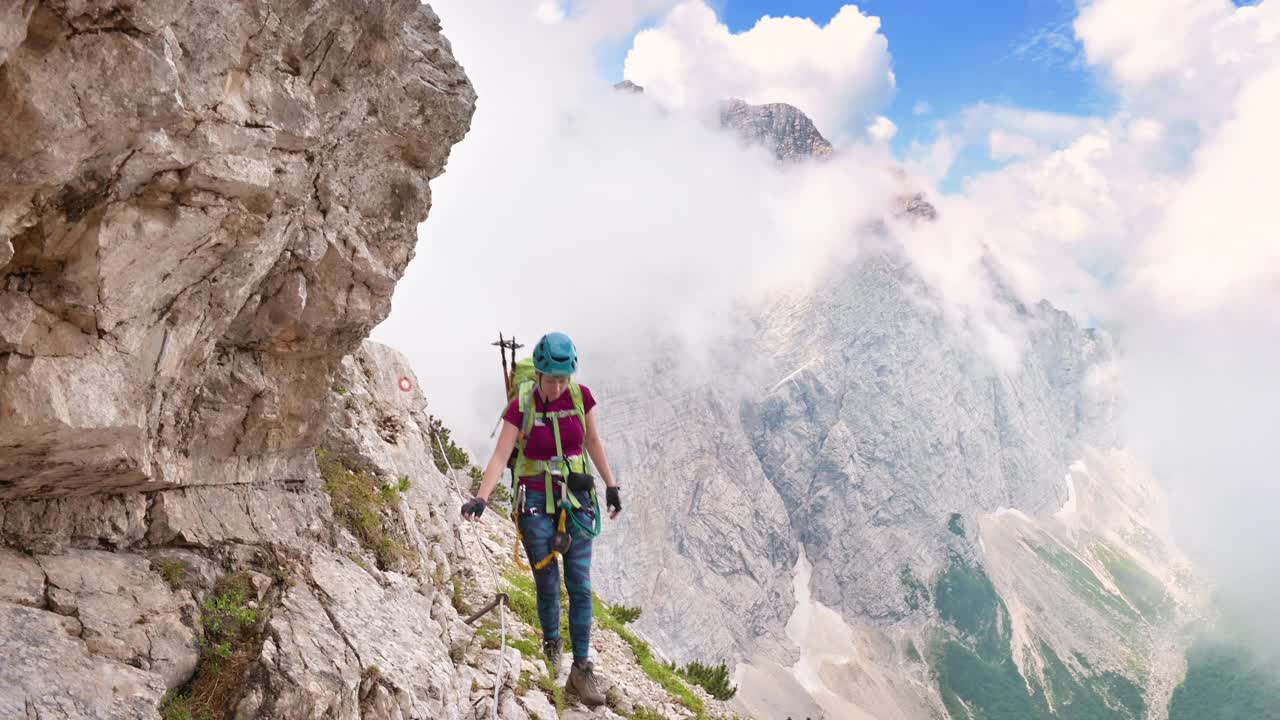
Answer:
xmin=598 ymin=245 xmax=1193 ymax=720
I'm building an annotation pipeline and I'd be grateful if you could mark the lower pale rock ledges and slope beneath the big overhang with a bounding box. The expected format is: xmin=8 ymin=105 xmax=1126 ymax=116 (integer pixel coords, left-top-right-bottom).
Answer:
xmin=0 ymin=343 xmax=728 ymax=720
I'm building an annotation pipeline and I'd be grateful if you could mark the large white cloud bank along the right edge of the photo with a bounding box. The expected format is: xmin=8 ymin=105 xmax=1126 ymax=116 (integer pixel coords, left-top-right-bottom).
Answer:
xmin=920 ymin=0 xmax=1280 ymax=642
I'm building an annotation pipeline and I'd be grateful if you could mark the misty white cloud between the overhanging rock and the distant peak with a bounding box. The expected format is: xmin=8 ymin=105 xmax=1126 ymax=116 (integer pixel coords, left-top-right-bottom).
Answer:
xmin=375 ymin=0 xmax=892 ymax=454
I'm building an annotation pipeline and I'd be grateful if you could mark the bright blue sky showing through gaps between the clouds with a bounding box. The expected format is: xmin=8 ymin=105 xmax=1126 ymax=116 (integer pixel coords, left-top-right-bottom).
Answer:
xmin=607 ymin=0 xmax=1112 ymax=190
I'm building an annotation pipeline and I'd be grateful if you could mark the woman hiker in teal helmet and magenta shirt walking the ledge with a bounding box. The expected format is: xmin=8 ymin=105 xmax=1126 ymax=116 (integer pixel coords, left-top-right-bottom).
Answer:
xmin=462 ymin=333 xmax=622 ymax=706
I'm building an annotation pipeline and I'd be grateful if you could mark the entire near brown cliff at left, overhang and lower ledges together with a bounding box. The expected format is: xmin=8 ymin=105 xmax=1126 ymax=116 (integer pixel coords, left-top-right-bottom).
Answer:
xmin=0 ymin=0 xmax=747 ymax=720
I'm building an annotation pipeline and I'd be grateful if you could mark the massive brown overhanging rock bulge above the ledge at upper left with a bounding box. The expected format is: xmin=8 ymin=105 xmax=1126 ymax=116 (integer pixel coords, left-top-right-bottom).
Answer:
xmin=0 ymin=0 xmax=475 ymax=498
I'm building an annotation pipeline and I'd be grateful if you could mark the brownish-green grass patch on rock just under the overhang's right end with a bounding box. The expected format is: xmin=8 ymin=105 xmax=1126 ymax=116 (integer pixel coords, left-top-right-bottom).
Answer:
xmin=316 ymin=447 xmax=417 ymax=570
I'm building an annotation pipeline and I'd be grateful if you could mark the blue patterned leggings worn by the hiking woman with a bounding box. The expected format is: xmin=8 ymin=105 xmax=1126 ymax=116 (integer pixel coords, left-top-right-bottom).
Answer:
xmin=520 ymin=484 xmax=595 ymax=660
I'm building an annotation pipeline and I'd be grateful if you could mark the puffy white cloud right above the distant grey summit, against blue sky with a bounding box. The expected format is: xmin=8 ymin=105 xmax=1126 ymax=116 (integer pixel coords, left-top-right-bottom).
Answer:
xmin=625 ymin=0 xmax=893 ymax=136
